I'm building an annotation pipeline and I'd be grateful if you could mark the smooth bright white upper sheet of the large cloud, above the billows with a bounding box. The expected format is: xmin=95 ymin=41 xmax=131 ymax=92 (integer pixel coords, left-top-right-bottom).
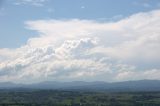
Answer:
xmin=28 ymin=11 xmax=160 ymax=61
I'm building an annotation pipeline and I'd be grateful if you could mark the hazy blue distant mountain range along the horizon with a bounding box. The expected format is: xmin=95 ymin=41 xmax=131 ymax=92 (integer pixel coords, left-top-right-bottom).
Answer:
xmin=0 ymin=80 xmax=160 ymax=91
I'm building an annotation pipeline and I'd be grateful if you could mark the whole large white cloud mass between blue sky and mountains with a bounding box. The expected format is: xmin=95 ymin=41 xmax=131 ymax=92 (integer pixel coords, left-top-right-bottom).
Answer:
xmin=0 ymin=10 xmax=160 ymax=83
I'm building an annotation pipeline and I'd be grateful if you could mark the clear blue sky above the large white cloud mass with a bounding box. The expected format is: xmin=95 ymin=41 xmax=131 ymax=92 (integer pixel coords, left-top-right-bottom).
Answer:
xmin=0 ymin=0 xmax=160 ymax=48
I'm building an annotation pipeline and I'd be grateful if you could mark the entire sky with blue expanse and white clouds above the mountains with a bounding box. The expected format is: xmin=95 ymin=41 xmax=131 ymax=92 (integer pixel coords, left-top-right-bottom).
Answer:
xmin=0 ymin=0 xmax=160 ymax=83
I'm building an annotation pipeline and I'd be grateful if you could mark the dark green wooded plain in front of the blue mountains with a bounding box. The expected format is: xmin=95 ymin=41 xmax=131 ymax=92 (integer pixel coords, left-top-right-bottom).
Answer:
xmin=0 ymin=90 xmax=160 ymax=106
